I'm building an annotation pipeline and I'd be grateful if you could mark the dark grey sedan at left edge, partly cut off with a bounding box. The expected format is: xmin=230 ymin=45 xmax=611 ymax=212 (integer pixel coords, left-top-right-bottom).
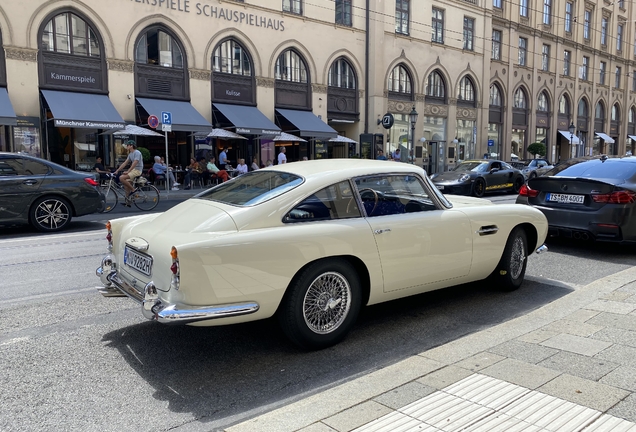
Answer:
xmin=0 ymin=152 xmax=104 ymax=231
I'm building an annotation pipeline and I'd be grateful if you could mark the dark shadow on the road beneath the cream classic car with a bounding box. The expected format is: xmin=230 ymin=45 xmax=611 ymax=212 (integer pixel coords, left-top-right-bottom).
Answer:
xmin=103 ymin=281 xmax=570 ymax=428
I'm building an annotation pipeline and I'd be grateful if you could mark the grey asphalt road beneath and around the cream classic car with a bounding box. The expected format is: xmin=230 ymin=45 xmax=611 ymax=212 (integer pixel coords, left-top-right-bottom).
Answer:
xmin=0 ymin=196 xmax=635 ymax=431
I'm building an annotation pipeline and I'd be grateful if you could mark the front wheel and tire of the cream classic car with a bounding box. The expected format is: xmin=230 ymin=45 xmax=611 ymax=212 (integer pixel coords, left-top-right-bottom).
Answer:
xmin=491 ymin=227 xmax=528 ymax=291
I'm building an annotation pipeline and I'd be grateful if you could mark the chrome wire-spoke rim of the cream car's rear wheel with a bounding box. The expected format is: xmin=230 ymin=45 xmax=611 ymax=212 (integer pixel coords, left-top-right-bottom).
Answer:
xmin=303 ymin=272 xmax=351 ymax=334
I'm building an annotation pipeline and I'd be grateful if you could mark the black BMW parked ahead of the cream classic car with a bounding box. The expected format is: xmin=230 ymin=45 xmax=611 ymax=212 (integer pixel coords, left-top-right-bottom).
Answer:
xmin=517 ymin=155 xmax=636 ymax=243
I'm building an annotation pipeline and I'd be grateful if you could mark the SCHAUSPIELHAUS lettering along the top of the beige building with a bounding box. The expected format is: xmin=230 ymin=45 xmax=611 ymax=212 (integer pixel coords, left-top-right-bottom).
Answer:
xmin=130 ymin=0 xmax=285 ymax=31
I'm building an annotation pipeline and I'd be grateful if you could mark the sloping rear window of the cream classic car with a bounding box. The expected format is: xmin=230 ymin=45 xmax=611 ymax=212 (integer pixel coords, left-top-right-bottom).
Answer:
xmin=197 ymin=171 xmax=303 ymax=206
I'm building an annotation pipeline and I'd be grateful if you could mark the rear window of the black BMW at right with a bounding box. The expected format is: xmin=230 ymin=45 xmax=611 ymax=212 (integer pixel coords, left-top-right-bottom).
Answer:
xmin=547 ymin=159 xmax=636 ymax=180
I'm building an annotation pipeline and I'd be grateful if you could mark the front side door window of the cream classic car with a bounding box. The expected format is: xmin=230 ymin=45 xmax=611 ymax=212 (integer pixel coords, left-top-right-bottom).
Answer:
xmin=355 ymin=175 xmax=437 ymax=217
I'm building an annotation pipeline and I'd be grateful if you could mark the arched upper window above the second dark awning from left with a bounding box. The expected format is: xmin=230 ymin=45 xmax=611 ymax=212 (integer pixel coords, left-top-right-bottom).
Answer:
xmin=135 ymin=28 xmax=184 ymax=69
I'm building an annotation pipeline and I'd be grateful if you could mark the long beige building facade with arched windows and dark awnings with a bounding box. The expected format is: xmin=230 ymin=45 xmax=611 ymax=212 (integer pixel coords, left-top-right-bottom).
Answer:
xmin=0 ymin=0 xmax=636 ymax=172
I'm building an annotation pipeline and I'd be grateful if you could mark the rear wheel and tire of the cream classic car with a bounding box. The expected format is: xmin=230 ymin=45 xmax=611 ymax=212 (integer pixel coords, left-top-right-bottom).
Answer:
xmin=278 ymin=259 xmax=361 ymax=350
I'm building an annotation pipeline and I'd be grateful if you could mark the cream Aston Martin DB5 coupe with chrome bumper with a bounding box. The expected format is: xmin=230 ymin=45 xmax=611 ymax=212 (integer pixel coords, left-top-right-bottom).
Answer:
xmin=97 ymin=159 xmax=548 ymax=349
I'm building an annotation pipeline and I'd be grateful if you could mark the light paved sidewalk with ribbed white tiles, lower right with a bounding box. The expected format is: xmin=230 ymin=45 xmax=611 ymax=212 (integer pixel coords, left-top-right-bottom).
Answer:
xmin=225 ymin=267 xmax=636 ymax=432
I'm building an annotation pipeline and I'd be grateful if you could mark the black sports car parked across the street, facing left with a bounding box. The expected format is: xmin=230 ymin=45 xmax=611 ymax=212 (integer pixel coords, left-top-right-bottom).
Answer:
xmin=431 ymin=159 xmax=525 ymax=197
